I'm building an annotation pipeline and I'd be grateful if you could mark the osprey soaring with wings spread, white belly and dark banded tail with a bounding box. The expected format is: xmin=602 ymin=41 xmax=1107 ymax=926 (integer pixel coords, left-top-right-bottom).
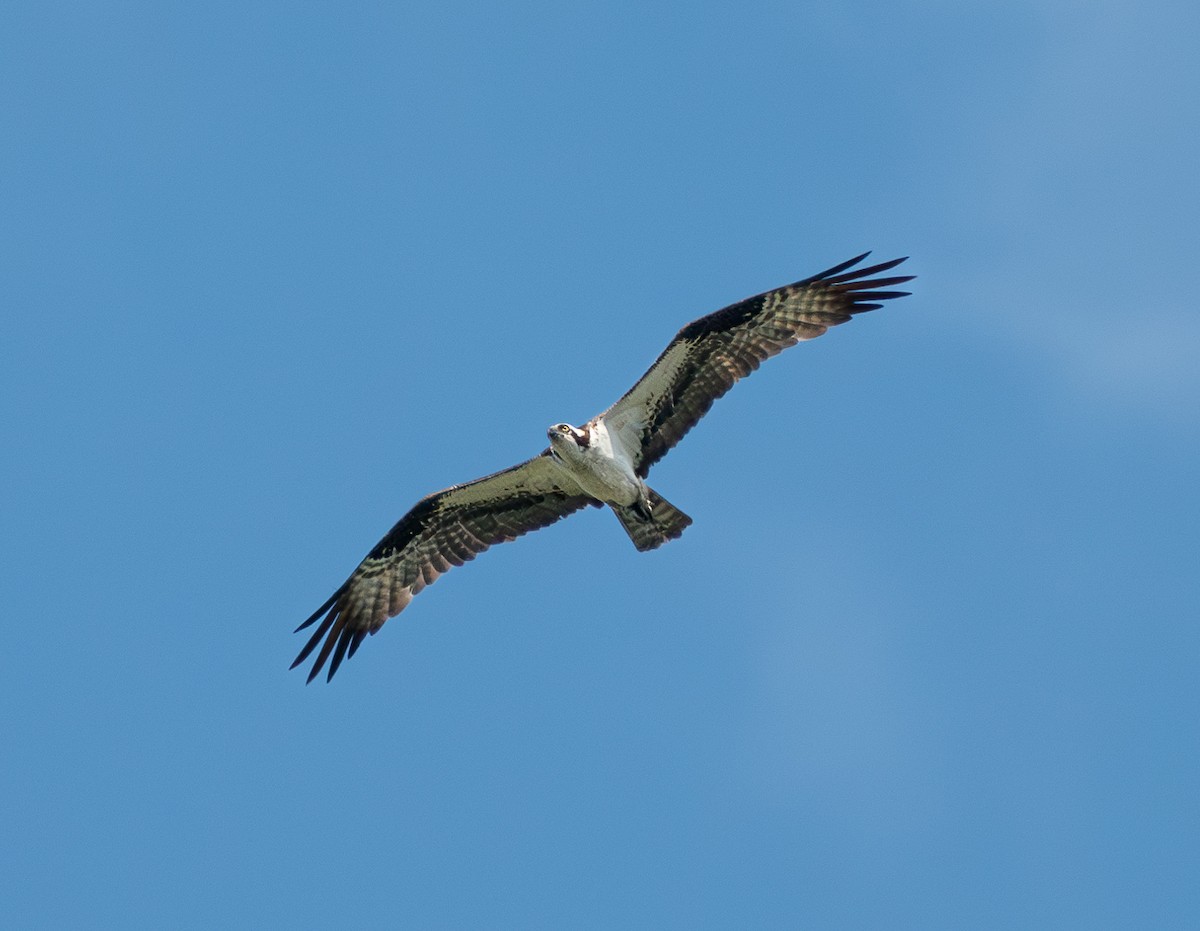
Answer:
xmin=292 ymin=253 xmax=913 ymax=681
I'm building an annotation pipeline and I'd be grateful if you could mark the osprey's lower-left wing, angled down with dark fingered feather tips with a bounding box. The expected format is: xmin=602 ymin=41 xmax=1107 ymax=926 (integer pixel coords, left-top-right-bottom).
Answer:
xmin=292 ymin=450 xmax=592 ymax=681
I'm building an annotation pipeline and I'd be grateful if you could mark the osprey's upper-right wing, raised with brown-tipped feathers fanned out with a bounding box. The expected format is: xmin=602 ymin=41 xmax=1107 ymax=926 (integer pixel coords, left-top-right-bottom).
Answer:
xmin=601 ymin=252 xmax=913 ymax=479
